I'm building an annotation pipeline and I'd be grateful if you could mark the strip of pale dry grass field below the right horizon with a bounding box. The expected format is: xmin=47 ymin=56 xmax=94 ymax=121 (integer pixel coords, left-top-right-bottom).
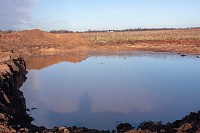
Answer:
xmin=83 ymin=29 xmax=200 ymax=43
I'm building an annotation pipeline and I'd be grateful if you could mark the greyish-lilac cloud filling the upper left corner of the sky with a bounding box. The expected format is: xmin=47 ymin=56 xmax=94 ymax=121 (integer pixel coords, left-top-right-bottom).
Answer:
xmin=0 ymin=0 xmax=37 ymax=30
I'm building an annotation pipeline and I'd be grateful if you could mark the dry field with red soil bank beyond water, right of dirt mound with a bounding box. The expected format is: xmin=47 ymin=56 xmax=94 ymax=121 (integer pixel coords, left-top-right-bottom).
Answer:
xmin=83 ymin=29 xmax=200 ymax=54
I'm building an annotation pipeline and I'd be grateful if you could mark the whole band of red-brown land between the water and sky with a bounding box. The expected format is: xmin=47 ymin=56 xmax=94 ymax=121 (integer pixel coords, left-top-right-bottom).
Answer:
xmin=0 ymin=29 xmax=200 ymax=59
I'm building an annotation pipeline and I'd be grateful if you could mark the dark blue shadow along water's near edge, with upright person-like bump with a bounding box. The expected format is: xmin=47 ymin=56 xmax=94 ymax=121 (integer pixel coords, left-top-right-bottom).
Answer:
xmin=26 ymin=87 xmax=200 ymax=130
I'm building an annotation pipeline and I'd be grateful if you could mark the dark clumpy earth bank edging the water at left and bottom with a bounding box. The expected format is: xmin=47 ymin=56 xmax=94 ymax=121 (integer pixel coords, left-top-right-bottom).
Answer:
xmin=0 ymin=58 xmax=200 ymax=133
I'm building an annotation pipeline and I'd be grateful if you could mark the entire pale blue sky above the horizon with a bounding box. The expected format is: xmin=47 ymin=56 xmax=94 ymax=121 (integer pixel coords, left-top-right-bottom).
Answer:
xmin=0 ymin=0 xmax=200 ymax=31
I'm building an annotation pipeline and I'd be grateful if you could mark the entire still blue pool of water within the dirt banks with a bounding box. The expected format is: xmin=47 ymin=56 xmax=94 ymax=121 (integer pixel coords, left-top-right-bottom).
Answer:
xmin=22 ymin=53 xmax=200 ymax=130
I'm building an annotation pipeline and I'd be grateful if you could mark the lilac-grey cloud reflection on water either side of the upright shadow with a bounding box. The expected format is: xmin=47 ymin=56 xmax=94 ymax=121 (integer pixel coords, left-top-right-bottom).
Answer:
xmin=38 ymin=85 xmax=156 ymax=113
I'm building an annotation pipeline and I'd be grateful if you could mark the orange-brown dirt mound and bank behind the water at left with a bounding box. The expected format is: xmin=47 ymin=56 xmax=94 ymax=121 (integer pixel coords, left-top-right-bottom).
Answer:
xmin=0 ymin=29 xmax=91 ymax=55
